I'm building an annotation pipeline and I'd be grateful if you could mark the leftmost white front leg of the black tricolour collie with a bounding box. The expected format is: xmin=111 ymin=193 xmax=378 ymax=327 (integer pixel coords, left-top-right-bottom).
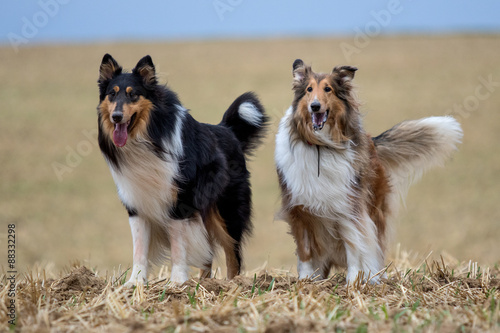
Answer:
xmin=125 ymin=215 xmax=151 ymax=288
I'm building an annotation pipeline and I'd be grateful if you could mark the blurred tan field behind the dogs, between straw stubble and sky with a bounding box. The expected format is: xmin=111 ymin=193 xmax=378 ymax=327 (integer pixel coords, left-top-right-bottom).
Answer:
xmin=0 ymin=35 xmax=500 ymax=271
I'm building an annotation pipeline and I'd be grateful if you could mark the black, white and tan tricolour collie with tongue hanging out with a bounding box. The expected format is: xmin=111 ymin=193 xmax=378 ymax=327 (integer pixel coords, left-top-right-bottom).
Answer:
xmin=97 ymin=54 xmax=268 ymax=286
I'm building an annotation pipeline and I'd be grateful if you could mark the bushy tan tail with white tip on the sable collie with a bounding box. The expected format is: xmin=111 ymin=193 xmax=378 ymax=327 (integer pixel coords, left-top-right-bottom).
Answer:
xmin=372 ymin=116 xmax=463 ymax=198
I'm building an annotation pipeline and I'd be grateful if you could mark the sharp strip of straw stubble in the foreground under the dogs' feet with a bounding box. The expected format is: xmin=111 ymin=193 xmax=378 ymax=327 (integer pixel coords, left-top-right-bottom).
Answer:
xmin=0 ymin=253 xmax=500 ymax=333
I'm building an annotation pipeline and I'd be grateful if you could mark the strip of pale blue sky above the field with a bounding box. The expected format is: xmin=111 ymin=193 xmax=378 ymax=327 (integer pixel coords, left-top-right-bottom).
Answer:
xmin=0 ymin=0 xmax=500 ymax=46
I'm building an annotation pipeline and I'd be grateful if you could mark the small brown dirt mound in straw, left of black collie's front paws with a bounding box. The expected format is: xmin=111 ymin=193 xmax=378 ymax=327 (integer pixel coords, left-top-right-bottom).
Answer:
xmin=51 ymin=266 xmax=106 ymax=299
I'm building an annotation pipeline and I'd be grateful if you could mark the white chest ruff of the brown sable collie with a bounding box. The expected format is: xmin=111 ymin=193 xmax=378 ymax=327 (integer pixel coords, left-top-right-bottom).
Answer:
xmin=275 ymin=108 xmax=356 ymax=218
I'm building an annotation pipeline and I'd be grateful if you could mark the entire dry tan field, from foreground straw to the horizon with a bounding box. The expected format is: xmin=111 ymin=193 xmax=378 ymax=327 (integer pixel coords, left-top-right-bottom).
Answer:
xmin=0 ymin=35 xmax=500 ymax=332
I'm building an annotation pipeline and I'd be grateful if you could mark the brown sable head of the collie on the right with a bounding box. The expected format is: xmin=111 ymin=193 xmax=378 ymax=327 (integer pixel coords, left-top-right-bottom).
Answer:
xmin=292 ymin=59 xmax=359 ymax=147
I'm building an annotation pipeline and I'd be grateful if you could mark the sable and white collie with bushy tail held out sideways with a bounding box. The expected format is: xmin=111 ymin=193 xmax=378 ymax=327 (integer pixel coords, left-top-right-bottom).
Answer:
xmin=275 ymin=59 xmax=462 ymax=283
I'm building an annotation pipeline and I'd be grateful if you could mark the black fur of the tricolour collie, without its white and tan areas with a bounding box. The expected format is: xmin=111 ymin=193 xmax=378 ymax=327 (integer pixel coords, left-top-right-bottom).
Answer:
xmin=98 ymin=55 xmax=269 ymax=274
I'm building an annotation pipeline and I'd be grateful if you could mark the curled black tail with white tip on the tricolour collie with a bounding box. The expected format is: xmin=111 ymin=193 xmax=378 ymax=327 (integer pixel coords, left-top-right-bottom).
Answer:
xmin=220 ymin=92 xmax=269 ymax=155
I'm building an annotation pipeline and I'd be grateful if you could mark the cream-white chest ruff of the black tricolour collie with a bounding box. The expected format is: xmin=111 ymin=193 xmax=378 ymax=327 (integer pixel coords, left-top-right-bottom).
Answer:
xmin=110 ymin=137 xmax=178 ymax=223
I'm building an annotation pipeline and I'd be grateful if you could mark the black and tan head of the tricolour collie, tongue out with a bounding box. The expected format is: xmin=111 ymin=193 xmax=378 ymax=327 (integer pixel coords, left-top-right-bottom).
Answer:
xmin=97 ymin=54 xmax=157 ymax=147
